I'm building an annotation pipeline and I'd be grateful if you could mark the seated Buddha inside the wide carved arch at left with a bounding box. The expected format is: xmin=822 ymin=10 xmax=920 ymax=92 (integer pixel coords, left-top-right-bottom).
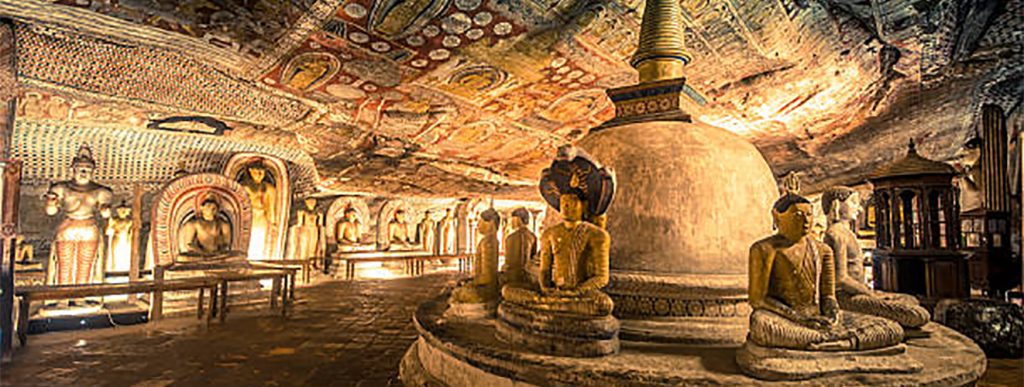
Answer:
xmin=178 ymin=197 xmax=237 ymax=261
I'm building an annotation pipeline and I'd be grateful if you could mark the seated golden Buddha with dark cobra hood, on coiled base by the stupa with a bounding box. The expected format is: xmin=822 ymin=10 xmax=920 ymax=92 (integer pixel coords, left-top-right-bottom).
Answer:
xmin=498 ymin=148 xmax=618 ymax=357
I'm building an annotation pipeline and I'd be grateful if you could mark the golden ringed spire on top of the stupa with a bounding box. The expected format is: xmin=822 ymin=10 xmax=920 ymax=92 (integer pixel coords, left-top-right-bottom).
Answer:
xmin=630 ymin=0 xmax=690 ymax=83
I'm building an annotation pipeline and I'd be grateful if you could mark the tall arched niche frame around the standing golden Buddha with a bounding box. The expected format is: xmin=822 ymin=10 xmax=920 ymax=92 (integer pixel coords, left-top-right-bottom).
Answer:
xmin=224 ymin=153 xmax=292 ymax=259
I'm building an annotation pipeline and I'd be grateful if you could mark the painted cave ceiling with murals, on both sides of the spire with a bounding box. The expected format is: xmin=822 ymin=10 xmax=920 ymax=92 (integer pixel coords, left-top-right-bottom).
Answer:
xmin=0 ymin=0 xmax=1024 ymax=197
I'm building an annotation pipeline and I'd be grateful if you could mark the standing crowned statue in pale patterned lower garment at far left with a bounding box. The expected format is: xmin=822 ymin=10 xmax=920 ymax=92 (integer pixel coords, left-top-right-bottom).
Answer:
xmin=44 ymin=145 xmax=114 ymax=285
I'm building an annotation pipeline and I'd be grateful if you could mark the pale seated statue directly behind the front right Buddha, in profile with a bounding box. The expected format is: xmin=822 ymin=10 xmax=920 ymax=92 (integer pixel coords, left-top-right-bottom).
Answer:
xmin=821 ymin=186 xmax=931 ymax=328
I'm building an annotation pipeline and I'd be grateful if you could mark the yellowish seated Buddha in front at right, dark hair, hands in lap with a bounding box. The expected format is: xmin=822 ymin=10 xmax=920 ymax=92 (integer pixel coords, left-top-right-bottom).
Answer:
xmin=736 ymin=194 xmax=921 ymax=379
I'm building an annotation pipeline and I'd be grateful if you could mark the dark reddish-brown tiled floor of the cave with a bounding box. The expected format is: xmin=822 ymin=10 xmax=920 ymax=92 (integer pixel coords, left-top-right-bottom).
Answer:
xmin=0 ymin=272 xmax=1024 ymax=387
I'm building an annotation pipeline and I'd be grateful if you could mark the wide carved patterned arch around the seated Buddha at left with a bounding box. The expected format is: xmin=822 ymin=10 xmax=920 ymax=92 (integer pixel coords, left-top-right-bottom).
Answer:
xmin=150 ymin=173 xmax=252 ymax=266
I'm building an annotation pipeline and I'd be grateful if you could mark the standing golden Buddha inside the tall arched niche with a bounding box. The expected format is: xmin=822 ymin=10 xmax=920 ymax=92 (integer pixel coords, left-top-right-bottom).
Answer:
xmin=242 ymin=162 xmax=279 ymax=259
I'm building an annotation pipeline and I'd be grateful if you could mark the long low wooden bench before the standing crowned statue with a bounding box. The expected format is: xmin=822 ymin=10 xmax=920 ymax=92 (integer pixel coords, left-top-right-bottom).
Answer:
xmin=14 ymin=278 xmax=219 ymax=347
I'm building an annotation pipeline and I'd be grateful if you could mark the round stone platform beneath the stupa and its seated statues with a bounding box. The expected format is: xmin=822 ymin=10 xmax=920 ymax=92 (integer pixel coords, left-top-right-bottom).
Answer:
xmin=400 ymin=297 xmax=986 ymax=387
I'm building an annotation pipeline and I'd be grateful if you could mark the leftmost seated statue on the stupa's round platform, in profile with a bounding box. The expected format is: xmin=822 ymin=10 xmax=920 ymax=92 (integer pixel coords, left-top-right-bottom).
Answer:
xmin=449 ymin=209 xmax=501 ymax=307
